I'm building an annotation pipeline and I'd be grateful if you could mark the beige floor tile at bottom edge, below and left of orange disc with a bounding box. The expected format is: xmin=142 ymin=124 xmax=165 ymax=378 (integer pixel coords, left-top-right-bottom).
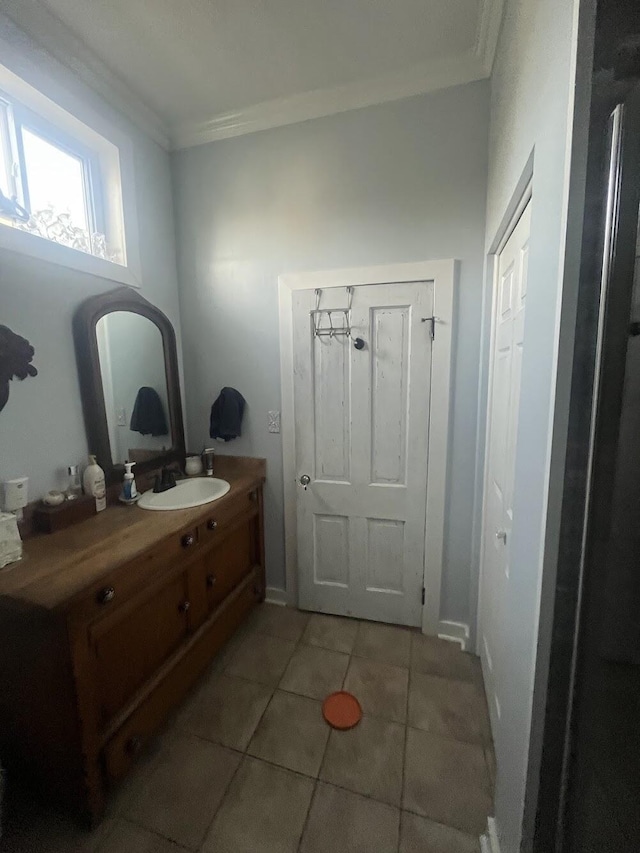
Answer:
xmin=202 ymin=758 xmax=314 ymax=853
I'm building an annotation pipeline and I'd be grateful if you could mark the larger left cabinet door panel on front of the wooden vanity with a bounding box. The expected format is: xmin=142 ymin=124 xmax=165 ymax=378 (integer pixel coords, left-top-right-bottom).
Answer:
xmin=91 ymin=574 xmax=188 ymax=723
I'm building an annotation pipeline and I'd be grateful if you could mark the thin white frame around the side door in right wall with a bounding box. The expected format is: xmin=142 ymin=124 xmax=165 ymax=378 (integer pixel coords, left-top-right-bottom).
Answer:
xmin=475 ymin=183 xmax=533 ymax=657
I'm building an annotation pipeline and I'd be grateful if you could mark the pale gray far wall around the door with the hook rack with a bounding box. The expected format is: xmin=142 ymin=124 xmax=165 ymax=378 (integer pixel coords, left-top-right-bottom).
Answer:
xmin=173 ymin=82 xmax=488 ymax=622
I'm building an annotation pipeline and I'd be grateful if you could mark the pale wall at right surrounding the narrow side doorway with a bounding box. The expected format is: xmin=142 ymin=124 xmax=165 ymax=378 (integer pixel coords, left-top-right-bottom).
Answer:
xmin=475 ymin=0 xmax=590 ymax=853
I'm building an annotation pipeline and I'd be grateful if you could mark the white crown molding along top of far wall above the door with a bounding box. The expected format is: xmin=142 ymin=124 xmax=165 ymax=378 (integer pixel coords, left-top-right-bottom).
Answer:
xmin=170 ymin=48 xmax=488 ymax=149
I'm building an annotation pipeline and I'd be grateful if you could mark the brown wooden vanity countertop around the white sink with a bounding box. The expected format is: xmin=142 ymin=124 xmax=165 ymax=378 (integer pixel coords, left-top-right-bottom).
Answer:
xmin=0 ymin=456 xmax=266 ymax=610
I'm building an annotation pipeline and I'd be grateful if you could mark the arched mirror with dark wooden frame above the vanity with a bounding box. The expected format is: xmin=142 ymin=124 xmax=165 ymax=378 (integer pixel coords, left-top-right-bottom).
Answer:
xmin=73 ymin=287 xmax=185 ymax=483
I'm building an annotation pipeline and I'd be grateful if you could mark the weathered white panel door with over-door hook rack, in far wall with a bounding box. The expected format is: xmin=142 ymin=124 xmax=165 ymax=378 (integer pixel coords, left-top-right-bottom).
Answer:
xmin=293 ymin=282 xmax=433 ymax=625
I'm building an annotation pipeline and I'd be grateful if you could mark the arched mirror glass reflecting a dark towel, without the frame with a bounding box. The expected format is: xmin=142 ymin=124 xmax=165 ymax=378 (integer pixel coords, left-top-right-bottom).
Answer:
xmin=96 ymin=311 xmax=173 ymax=465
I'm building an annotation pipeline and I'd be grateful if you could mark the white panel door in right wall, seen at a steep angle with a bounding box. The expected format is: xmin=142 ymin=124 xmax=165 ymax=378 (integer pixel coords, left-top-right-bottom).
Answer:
xmin=480 ymin=202 xmax=531 ymax=718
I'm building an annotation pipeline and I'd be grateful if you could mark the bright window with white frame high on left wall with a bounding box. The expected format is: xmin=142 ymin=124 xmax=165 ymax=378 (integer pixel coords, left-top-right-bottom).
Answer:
xmin=0 ymin=60 xmax=141 ymax=287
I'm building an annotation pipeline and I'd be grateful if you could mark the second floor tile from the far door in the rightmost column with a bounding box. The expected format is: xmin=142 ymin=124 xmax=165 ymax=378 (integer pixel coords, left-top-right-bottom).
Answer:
xmin=407 ymin=672 xmax=491 ymax=743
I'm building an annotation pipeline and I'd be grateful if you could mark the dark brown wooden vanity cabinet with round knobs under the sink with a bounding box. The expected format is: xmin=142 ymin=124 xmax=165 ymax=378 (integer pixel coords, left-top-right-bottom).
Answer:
xmin=0 ymin=470 xmax=264 ymax=822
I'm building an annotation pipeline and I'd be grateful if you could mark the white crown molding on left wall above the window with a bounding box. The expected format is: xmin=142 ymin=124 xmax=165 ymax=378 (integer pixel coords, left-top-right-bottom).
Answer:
xmin=2 ymin=0 xmax=170 ymax=150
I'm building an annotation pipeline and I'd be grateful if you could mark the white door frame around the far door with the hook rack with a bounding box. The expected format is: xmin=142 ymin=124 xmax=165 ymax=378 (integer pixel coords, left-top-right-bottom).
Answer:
xmin=278 ymin=260 xmax=458 ymax=634
